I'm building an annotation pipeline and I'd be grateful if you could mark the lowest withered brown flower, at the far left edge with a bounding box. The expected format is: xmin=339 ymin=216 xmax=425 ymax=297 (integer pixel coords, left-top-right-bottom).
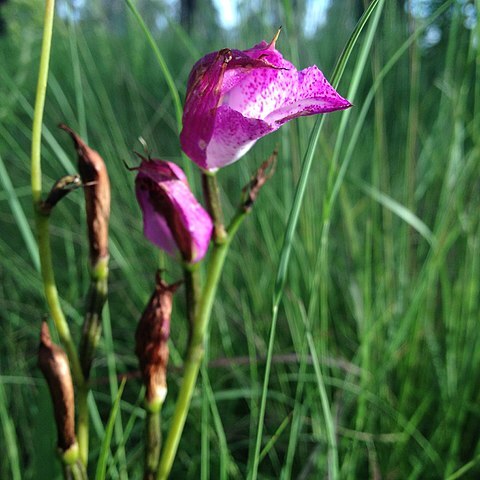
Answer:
xmin=38 ymin=322 xmax=76 ymax=452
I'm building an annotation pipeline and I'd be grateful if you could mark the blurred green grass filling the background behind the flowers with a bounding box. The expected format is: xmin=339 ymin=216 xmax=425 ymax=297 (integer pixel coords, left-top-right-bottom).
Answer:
xmin=0 ymin=0 xmax=480 ymax=480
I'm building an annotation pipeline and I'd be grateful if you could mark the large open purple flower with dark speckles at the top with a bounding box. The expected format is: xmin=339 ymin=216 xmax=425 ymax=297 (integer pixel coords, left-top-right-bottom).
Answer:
xmin=180 ymin=34 xmax=351 ymax=170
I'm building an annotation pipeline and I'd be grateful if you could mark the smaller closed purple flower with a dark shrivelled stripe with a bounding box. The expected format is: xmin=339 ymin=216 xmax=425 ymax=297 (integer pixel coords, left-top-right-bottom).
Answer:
xmin=135 ymin=158 xmax=213 ymax=263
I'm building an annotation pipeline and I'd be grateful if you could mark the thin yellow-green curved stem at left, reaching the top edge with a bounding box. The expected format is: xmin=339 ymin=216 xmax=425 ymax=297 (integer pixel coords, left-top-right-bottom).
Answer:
xmin=31 ymin=0 xmax=83 ymax=385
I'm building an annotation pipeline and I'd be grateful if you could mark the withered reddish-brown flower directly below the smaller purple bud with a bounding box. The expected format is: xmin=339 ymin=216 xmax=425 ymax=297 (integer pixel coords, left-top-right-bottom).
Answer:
xmin=135 ymin=272 xmax=181 ymax=406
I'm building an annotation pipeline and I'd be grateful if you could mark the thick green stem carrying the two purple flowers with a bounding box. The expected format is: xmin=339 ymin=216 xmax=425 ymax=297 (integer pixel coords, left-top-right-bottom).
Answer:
xmin=157 ymin=211 xmax=247 ymax=480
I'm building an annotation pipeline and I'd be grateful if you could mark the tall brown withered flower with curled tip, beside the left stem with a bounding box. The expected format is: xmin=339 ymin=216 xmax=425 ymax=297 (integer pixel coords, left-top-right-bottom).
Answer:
xmin=59 ymin=124 xmax=110 ymax=266
